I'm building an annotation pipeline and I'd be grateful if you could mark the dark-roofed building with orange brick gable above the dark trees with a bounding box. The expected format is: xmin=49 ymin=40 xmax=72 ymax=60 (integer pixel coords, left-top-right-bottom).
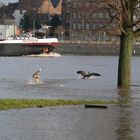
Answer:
xmin=13 ymin=0 xmax=62 ymax=26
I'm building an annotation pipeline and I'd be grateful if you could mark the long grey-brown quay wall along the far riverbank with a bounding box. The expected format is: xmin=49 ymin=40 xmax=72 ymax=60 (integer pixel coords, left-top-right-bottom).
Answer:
xmin=55 ymin=43 xmax=140 ymax=55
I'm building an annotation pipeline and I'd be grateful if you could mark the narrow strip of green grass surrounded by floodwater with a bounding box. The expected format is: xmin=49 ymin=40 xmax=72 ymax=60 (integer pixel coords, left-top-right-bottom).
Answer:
xmin=0 ymin=99 xmax=116 ymax=110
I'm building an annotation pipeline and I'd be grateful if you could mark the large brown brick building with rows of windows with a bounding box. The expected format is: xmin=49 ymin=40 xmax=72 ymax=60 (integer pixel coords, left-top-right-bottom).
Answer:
xmin=62 ymin=0 xmax=118 ymax=42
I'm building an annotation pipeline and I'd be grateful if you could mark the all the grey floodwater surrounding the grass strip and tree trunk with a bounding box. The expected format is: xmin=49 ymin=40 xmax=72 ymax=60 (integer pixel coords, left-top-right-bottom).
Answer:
xmin=0 ymin=56 xmax=140 ymax=140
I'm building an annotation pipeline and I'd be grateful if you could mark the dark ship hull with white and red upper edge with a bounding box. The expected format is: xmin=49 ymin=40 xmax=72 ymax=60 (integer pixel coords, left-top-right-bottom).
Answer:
xmin=0 ymin=39 xmax=60 ymax=56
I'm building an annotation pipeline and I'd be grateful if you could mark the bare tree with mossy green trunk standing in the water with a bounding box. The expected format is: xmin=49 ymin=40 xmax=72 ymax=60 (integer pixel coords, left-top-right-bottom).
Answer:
xmin=103 ymin=0 xmax=140 ymax=88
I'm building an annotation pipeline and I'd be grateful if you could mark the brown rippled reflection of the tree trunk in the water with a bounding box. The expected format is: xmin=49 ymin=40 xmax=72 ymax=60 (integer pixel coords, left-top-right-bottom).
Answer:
xmin=116 ymin=90 xmax=134 ymax=140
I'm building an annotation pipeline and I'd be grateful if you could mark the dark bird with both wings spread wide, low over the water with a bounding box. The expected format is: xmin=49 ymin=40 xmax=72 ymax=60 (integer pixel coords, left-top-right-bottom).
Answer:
xmin=77 ymin=70 xmax=101 ymax=79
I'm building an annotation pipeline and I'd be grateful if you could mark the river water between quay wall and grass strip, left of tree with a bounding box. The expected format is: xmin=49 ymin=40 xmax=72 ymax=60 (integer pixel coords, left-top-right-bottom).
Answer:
xmin=0 ymin=56 xmax=118 ymax=99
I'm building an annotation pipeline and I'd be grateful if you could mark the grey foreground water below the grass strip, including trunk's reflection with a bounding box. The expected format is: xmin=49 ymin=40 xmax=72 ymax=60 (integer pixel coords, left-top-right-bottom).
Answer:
xmin=0 ymin=103 xmax=140 ymax=140
